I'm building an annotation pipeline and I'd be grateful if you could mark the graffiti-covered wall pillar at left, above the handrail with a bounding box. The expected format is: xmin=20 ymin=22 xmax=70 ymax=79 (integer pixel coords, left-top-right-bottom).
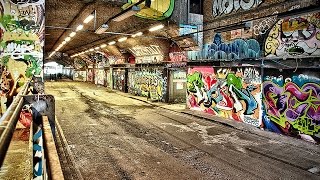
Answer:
xmin=0 ymin=0 xmax=45 ymax=115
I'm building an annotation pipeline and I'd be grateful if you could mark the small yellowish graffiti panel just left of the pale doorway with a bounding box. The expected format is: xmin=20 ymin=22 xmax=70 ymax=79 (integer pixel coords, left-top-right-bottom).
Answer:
xmin=129 ymin=69 xmax=167 ymax=101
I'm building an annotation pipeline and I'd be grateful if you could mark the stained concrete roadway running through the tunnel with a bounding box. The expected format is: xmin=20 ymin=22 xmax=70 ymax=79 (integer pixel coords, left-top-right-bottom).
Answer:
xmin=45 ymin=82 xmax=320 ymax=180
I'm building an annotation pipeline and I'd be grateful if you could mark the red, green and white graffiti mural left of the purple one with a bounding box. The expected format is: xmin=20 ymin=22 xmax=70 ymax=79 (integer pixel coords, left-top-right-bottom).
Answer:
xmin=187 ymin=67 xmax=261 ymax=127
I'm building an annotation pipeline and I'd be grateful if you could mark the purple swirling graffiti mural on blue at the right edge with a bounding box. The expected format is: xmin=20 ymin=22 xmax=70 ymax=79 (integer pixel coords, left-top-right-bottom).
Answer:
xmin=262 ymin=71 xmax=320 ymax=142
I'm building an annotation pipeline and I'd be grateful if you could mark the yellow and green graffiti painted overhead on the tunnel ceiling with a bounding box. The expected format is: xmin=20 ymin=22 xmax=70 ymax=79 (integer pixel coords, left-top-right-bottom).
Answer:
xmin=122 ymin=0 xmax=174 ymax=20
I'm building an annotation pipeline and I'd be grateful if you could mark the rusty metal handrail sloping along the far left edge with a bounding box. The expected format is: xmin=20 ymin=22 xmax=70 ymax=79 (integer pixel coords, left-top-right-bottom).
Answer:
xmin=0 ymin=81 xmax=30 ymax=166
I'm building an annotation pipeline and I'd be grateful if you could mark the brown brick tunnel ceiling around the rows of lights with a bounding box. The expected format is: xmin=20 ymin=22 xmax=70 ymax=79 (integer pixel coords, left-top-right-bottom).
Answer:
xmin=44 ymin=0 xmax=184 ymax=66
